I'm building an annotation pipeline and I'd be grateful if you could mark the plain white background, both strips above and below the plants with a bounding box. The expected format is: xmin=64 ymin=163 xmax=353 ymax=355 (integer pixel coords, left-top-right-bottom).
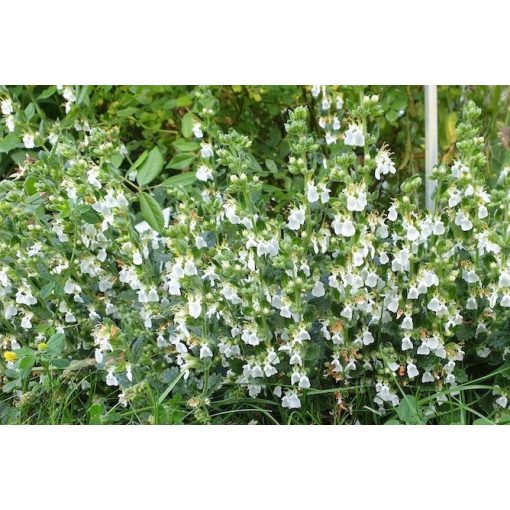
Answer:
xmin=0 ymin=0 xmax=510 ymax=510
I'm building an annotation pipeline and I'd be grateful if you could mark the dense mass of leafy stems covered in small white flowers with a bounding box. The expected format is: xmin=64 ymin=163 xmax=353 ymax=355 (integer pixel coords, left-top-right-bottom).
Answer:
xmin=0 ymin=87 xmax=510 ymax=422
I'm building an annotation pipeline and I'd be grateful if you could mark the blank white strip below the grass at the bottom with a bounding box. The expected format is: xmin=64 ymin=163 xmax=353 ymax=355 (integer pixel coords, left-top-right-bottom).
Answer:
xmin=0 ymin=426 xmax=510 ymax=510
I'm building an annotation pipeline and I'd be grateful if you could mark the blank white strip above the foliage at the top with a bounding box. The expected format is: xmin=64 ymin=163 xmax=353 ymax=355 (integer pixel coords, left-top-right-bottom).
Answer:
xmin=0 ymin=0 xmax=510 ymax=84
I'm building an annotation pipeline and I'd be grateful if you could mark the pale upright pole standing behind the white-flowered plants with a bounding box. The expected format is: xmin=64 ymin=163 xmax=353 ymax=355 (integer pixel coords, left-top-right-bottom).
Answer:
xmin=425 ymin=85 xmax=438 ymax=212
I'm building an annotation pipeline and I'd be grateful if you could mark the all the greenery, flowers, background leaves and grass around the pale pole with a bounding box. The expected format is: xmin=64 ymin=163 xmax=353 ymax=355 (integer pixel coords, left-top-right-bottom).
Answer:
xmin=0 ymin=86 xmax=510 ymax=424
